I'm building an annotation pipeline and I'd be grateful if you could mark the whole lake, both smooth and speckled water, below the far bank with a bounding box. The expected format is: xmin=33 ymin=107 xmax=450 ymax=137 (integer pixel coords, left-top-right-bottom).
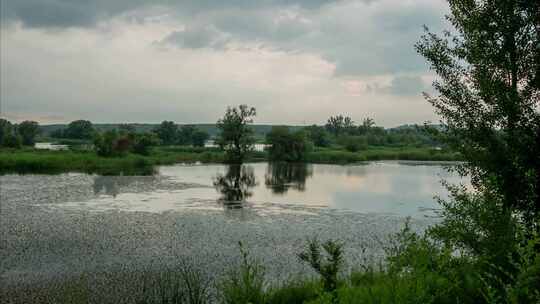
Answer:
xmin=0 ymin=162 xmax=462 ymax=294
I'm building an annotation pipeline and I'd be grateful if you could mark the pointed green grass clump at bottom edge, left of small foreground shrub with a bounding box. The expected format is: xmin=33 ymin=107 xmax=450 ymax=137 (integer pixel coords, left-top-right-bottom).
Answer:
xmin=218 ymin=242 xmax=266 ymax=304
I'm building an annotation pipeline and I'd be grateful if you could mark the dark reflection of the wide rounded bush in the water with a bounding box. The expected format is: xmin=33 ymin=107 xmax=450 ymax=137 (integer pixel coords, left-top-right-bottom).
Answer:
xmin=265 ymin=162 xmax=313 ymax=194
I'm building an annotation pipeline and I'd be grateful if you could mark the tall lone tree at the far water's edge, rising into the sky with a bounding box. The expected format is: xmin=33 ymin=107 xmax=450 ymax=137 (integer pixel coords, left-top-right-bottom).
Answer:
xmin=217 ymin=105 xmax=257 ymax=163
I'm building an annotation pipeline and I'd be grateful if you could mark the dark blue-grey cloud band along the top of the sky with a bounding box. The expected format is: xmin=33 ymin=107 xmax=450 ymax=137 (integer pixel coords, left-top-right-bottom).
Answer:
xmin=2 ymin=0 xmax=448 ymax=76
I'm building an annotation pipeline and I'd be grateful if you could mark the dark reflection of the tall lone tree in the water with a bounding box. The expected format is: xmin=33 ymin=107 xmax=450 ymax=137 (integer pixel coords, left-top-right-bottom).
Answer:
xmin=214 ymin=165 xmax=257 ymax=204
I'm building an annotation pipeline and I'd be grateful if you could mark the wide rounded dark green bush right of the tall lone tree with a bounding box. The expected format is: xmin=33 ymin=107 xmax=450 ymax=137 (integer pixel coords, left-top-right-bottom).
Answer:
xmin=266 ymin=127 xmax=310 ymax=162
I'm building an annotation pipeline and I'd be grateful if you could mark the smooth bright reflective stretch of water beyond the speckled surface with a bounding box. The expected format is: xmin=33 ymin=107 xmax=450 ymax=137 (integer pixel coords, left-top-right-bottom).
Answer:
xmin=66 ymin=162 xmax=462 ymax=217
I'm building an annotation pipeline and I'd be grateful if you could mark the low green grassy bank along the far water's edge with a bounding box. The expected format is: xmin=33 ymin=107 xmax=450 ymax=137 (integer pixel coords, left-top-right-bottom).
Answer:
xmin=0 ymin=146 xmax=461 ymax=175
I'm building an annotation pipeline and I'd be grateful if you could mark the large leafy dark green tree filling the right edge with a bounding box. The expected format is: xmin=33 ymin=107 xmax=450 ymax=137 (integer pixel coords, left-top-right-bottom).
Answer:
xmin=416 ymin=0 xmax=540 ymax=224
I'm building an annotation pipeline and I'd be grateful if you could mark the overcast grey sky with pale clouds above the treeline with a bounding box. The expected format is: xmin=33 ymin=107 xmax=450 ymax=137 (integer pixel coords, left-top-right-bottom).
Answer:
xmin=0 ymin=0 xmax=447 ymax=127
